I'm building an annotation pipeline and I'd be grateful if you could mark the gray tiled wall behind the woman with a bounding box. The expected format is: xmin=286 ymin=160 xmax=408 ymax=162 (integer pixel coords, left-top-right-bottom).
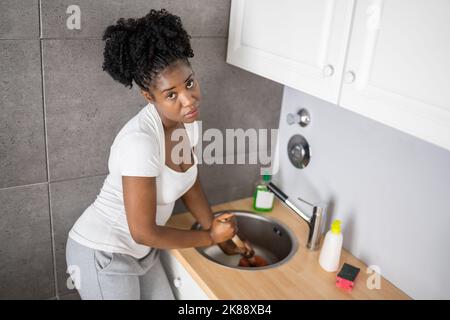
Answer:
xmin=0 ymin=0 xmax=282 ymax=299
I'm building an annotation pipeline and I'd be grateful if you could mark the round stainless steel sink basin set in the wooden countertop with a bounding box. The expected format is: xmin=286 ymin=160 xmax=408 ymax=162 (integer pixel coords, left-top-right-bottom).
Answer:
xmin=191 ymin=210 xmax=298 ymax=270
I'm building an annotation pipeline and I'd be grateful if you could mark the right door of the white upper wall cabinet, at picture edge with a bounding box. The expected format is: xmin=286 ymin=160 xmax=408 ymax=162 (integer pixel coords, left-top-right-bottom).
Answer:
xmin=339 ymin=0 xmax=450 ymax=150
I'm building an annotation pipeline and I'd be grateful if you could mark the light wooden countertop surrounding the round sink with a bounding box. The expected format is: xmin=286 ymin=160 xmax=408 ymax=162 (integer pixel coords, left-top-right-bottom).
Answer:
xmin=167 ymin=198 xmax=410 ymax=300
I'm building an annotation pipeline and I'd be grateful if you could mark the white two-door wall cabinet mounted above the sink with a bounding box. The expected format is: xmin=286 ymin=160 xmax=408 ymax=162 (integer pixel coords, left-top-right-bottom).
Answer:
xmin=227 ymin=0 xmax=450 ymax=150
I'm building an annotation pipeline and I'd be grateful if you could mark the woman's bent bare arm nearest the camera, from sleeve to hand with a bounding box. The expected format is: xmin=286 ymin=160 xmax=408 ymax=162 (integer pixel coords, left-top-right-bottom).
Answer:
xmin=122 ymin=176 xmax=236 ymax=249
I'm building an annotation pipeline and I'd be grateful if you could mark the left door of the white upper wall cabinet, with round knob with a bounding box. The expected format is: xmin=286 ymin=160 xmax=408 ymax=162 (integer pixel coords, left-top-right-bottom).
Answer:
xmin=227 ymin=0 xmax=354 ymax=103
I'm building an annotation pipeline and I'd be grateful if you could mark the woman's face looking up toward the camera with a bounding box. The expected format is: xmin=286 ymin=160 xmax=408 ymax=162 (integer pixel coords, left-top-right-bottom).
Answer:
xmin=142 ymin=60 xmax=201 ymax=127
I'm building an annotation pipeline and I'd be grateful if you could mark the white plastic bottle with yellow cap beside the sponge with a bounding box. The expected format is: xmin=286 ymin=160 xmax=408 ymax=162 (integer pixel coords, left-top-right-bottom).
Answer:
xmin=319 ymin=220 xmax=343 ymax=272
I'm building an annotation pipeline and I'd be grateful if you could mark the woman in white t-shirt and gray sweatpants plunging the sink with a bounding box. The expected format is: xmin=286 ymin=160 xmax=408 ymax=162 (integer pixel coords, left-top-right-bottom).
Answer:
xmin=66 ymin=9 xmax=250 ymax=299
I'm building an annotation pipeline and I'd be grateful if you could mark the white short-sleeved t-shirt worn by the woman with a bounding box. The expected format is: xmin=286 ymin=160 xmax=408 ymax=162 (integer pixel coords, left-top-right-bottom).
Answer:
xmin=69 ymin=103 xmax=198 ymax=259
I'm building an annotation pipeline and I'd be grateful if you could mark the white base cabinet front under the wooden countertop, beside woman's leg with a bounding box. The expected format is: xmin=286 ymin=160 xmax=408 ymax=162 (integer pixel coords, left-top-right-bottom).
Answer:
xmin=160 ymin=250 xmax=209 ymax=300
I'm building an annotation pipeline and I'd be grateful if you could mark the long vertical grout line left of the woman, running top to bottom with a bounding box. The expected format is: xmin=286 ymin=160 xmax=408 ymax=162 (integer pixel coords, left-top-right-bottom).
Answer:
xmin=38 ymin=0 xmax=59 ymax=300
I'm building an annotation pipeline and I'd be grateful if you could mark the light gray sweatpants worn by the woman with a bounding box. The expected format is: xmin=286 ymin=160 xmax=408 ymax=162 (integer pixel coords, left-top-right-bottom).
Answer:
xmin=66 ymin=238 xmax=175 ymax=300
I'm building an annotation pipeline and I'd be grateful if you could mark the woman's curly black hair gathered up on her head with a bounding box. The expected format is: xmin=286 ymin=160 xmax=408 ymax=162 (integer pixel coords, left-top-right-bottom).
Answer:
xmin=102 ymin=9 xmax=194 ymax=91
